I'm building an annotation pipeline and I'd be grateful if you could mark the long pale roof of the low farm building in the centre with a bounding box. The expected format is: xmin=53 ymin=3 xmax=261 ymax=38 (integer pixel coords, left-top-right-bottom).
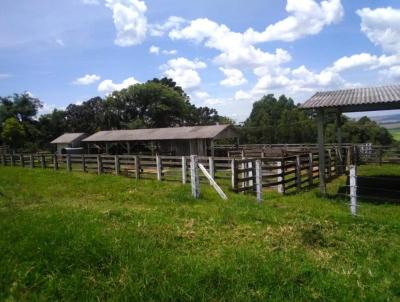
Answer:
xmin=83 ymin=125 xmax=236 ymax=142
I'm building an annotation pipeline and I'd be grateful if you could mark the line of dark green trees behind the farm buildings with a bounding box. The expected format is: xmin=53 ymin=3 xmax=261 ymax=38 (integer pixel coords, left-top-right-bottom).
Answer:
xmin=0 ymin=78 xmax=393 ymax=152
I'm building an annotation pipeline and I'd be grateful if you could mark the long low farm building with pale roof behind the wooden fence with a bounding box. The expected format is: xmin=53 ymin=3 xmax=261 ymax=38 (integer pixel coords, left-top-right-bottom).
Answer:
xmin=83 ymin=125 xmax=239 ymax=156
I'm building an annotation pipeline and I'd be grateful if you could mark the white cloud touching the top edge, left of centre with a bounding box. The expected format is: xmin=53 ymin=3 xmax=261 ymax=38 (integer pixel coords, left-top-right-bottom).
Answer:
xmin=106 ymin=0 xmax=148 ymax=47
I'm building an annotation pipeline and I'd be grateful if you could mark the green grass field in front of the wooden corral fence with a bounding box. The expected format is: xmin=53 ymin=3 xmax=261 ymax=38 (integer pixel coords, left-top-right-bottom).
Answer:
xmin=0 ymin=167 xmax=400 ymax=301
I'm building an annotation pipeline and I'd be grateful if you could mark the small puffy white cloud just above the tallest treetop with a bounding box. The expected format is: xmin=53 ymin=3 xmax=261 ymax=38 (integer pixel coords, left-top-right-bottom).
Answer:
xmin=161 ymin=57 xmax=207 ymax=90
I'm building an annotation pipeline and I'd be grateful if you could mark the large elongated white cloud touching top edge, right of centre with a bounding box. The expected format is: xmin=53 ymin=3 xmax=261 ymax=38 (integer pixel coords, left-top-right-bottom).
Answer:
xmin=244 ymin=0 xmax=344 ymax=43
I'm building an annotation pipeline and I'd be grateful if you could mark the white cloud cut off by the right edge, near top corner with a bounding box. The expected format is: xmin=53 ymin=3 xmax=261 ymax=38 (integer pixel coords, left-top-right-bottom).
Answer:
xmin=357 ymin=7 xmax=400 ymax=54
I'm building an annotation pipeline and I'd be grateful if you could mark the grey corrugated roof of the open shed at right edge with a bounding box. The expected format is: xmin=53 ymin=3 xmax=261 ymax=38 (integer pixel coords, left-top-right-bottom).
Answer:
xmin=302 ymin=85 xmax=400 ymax=109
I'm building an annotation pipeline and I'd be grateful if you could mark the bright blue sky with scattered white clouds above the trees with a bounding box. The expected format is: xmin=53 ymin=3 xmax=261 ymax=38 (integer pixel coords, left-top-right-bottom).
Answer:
xmin=0 ymin=0 xmax=400 ymax=122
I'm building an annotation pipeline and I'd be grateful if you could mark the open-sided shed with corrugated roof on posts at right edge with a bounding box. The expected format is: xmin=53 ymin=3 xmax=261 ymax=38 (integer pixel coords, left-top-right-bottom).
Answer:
xmin=302 ymin=85 xmax=400 ymax=194
